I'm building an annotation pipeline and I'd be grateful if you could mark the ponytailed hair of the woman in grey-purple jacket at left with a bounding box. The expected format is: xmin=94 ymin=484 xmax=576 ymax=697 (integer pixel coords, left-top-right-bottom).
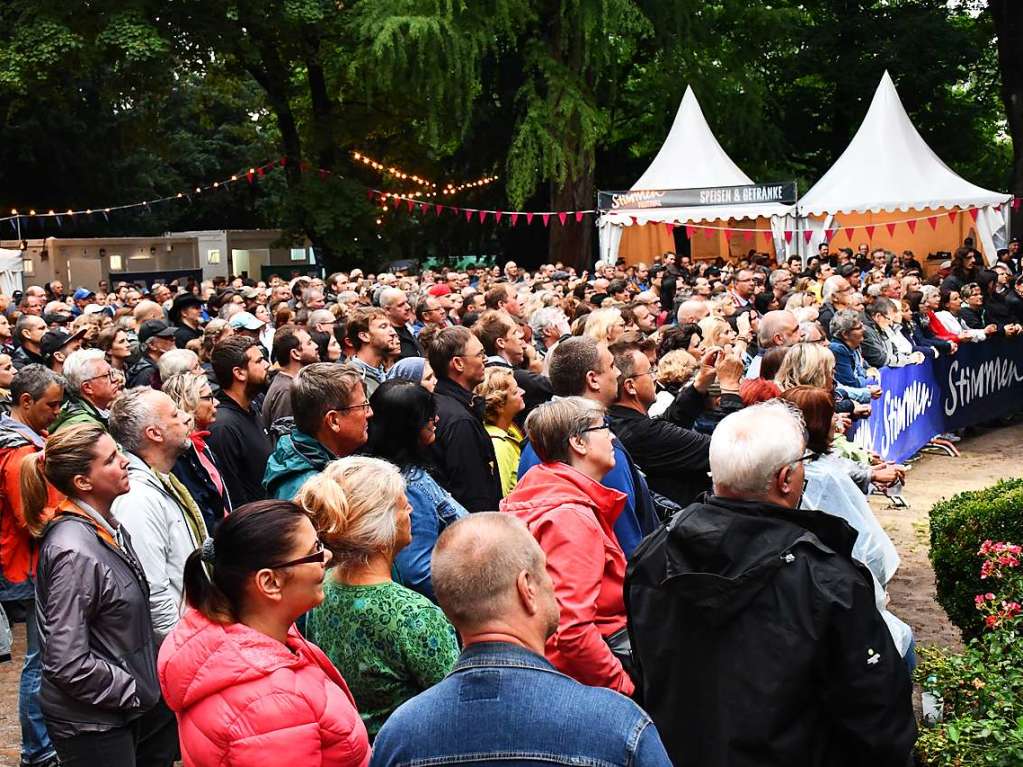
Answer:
xmin=19 ymin=423 xmax=106 ymax=538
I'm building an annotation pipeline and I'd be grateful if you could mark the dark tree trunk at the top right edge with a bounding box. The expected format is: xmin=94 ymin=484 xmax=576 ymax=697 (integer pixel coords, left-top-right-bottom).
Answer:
xmin=987 ymin=0 xmax=1023 ymax=235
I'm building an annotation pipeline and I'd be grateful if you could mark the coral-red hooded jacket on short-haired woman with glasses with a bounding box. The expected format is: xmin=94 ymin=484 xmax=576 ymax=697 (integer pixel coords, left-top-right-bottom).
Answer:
xmin=500 ymin=463 xmax=633 ymax=695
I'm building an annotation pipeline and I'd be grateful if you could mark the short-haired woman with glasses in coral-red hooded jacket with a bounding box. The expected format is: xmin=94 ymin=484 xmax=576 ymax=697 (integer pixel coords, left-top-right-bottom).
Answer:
xmin=500 ymin=397 xmax=635 ymax=695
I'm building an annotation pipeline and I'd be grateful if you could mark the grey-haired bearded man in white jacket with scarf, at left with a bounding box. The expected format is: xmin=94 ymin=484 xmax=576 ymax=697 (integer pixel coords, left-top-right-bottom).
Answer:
xmin=110 ymin=388 xmax=207 ymax=640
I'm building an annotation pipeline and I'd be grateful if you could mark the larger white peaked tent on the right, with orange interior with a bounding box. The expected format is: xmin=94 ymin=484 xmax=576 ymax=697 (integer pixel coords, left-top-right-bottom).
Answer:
xmin=786 ymin=72 xmax=1010 ymax=262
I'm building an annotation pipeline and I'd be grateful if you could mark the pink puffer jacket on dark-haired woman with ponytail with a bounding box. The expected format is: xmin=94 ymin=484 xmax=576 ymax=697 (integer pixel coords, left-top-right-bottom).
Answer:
xmin=157 ymin=610 xmax=369 ymax=767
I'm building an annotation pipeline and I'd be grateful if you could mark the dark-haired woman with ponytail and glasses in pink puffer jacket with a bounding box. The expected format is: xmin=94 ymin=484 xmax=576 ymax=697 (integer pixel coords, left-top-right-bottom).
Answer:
xmin=157 ymin=501 xmax=369 ymax=767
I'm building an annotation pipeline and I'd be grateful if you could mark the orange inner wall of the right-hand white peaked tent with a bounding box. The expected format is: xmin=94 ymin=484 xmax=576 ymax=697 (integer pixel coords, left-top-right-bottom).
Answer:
xmin=814 ymin=208 xmax=982 ymax=275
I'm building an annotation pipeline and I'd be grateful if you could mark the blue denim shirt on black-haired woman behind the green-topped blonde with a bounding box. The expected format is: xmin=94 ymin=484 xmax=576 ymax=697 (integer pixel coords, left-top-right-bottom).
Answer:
xmin=394 ymin=466 xmax=469 ymax=601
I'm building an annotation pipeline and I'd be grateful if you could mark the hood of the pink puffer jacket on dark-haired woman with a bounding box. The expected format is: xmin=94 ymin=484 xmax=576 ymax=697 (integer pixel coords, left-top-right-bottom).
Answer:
xmin=159 ymin=610 xmax=313 ymax=713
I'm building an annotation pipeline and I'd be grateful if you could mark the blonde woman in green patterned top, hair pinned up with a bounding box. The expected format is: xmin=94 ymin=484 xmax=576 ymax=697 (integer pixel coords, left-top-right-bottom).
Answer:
xmin=295 ymin=456 xmax=458 ymax=738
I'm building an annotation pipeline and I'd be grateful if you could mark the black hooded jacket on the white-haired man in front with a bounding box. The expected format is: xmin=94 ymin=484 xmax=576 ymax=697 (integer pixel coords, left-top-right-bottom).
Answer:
xmin=625 ymin=496 xmax=917 ymax=767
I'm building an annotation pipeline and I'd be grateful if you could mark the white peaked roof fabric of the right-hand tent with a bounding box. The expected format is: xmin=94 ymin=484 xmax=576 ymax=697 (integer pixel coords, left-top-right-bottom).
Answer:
xmin=798 ymin=72 xmax=1010 ymax=258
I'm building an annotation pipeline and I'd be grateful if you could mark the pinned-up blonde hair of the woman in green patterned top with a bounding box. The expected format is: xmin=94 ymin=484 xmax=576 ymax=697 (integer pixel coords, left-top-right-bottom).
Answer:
xmin=295 ymin=456 xmax=405 ymax=573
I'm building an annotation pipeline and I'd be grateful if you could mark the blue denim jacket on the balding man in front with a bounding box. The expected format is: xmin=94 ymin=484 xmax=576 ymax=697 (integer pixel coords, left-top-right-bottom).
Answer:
xmin=370 ymin=642 xmax=671 ymax=767
